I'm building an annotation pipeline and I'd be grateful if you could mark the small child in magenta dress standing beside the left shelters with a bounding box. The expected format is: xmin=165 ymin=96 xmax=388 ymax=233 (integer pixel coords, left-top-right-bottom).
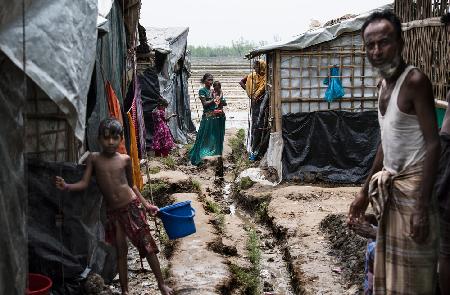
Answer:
xmin=151 ymin=98 xmax=177 ymax=157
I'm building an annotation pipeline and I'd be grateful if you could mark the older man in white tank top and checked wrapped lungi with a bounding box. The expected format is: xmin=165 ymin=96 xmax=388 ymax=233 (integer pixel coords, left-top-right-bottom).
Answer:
xmin=348 ymin=11 xmax=440 ymax=294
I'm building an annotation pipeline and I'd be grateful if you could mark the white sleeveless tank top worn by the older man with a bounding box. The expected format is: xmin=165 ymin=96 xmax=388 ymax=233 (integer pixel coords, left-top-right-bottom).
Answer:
xmin=378 ymin=66 xmax=426 ymax=174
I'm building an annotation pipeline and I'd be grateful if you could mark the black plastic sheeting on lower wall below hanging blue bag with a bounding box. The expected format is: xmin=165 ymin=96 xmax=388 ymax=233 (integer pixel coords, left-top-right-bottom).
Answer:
xmin=282 ymin=111 xmax=380 ymax=183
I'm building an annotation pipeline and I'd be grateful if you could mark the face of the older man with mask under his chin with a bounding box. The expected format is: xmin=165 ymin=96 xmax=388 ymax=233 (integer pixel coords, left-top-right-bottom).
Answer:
xmin=363 ymin=19 xmax=403 ymax=78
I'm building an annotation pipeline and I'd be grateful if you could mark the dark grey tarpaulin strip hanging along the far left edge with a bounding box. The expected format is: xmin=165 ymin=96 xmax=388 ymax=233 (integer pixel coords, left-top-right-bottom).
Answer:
xmin=0 ymin=52 xmax=26 ymax=295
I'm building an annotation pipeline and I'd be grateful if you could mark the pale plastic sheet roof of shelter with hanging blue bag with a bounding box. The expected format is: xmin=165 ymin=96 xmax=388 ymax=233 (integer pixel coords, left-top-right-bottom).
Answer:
xmin=247 ymin=4 xmax=393 ymax=58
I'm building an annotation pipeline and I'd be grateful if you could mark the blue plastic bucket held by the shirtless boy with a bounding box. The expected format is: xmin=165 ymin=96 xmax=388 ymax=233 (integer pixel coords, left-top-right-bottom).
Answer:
xmin=159 ymin=201 xmax=195 ymax=240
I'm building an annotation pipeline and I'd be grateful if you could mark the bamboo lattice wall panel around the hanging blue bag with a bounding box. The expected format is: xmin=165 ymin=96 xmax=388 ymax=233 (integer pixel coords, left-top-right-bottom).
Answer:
xmin=279 ymin=31 xmax=379 ymax=114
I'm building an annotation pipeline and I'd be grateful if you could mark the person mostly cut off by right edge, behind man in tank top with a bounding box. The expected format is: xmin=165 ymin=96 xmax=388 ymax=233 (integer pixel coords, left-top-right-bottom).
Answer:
xmin=436 ymin=13 xmax=450 ymax=294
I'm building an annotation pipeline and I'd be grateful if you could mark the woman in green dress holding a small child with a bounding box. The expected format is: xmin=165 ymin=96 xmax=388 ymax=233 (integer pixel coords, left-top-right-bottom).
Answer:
xmin=189 ymin=73 xmax=226 ymax=166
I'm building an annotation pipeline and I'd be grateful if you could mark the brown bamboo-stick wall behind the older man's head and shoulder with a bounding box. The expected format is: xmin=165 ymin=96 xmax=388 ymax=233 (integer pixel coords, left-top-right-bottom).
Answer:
xmin=394 ymin=0 xmax=450 ymax=99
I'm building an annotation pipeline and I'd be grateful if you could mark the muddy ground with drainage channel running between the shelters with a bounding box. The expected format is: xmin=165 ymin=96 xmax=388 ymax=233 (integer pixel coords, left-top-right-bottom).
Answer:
xmin=105 ymin=129 xmax=367 ymax=295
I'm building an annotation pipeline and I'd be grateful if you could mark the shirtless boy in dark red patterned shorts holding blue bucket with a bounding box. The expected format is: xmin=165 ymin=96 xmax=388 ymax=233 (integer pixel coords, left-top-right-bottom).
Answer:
xmin=56 ymin=118 xmax=173 ymax=295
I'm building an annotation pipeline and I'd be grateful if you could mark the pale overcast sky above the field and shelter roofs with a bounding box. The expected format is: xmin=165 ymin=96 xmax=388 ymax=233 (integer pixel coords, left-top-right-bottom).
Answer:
xmin=140 ymin=0 xmax=393 ymax=46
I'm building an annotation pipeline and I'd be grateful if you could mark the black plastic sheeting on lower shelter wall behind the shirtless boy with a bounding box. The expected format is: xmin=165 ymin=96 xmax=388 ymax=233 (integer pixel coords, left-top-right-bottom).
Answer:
xmin=27 ymin=160 xmax=116 ymax=295
